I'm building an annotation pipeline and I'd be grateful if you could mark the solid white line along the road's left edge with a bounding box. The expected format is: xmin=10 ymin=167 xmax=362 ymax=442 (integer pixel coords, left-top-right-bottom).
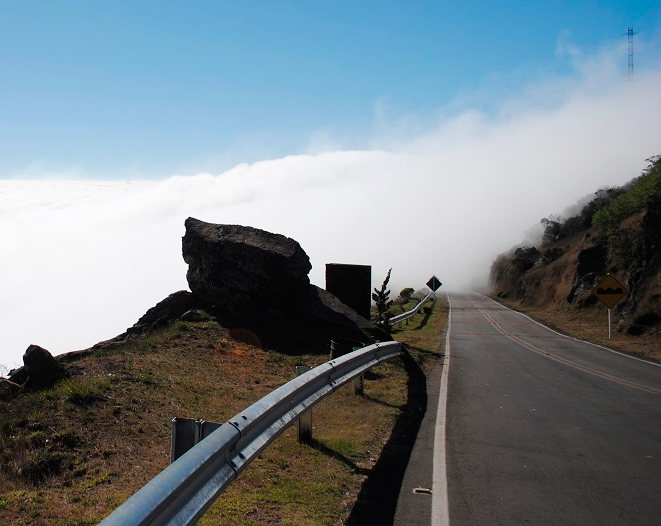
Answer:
xmin=431 ymin=294 xmax=452 ymax=526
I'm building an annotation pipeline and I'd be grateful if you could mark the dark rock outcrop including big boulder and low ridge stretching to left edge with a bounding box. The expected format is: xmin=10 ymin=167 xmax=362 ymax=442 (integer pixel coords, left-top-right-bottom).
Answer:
xmin=0 ymin=218 xmax=390 ymax=398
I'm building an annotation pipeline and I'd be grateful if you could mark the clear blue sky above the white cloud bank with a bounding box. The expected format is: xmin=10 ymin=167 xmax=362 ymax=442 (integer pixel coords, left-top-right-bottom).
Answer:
xmin=0 ymin=0 xmax=661 ymax=179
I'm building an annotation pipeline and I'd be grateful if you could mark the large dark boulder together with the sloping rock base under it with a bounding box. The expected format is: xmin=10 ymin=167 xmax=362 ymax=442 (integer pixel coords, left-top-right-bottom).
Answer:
xmin=182 ymin=218 xmax=390 ymax=353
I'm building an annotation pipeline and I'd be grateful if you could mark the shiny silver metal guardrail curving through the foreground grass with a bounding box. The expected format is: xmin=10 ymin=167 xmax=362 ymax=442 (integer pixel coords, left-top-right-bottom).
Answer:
xmin=100 ymin=341 xmax=403 ymax=526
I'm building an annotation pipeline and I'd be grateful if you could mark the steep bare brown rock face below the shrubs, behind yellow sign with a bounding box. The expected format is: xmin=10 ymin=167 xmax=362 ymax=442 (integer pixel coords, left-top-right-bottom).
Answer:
xmin=490 ymin=206 xmax=661 ymax=335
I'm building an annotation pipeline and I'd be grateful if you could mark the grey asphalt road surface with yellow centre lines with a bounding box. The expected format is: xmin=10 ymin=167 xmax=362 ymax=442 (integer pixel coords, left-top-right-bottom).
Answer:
xmin=445 ymin=294 xmax=661 ymax=525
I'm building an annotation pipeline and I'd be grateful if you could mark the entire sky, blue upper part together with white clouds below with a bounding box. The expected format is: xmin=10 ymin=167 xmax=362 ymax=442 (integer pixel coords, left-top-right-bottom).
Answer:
xmin=0 ymin=0 xmax=661 ymax=374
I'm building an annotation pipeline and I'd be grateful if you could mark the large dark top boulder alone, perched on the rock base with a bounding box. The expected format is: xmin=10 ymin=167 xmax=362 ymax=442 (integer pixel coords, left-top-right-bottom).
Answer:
xmin=182 ymin=217 xmax=312 ymax=317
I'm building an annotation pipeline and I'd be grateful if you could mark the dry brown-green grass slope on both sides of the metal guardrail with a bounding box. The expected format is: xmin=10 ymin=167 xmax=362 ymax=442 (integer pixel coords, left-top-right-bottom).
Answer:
xmin=0 ymin=303 xmax=446 ymax=526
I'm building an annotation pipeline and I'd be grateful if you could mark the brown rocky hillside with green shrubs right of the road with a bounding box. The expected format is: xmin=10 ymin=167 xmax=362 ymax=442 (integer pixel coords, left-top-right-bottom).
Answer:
xmin=490 ymin=156 xmax=661 ymax=361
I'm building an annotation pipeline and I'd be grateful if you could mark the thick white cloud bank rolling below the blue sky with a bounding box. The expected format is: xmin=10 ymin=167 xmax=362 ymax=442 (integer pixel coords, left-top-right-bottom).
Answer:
xmin=0 ymin=52 xmax=661 ymax=368
